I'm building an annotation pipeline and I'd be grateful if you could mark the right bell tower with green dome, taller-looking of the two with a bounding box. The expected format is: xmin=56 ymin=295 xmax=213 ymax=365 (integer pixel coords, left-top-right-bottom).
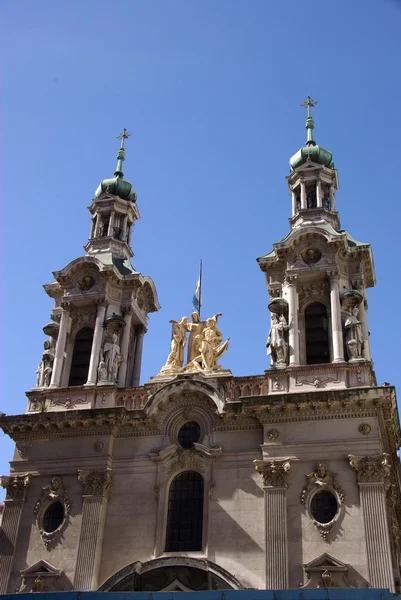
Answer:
xmin=258 ymin=96 xmax=375 ymax=393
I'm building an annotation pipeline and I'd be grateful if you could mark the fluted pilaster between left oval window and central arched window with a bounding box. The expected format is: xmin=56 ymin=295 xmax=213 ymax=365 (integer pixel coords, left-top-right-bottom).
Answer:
xmin=74 ymin=469 xmax=112 ymax=591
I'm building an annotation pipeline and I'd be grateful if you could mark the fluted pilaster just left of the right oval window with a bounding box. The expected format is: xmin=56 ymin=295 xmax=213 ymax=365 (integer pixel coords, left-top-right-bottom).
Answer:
xmin=255 ymin=459 xmax=290 ymax=590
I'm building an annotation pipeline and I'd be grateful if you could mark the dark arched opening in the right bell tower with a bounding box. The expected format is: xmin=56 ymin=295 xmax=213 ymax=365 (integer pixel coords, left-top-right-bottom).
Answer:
xmin=305 ymin=302 xmax=330 ymax=365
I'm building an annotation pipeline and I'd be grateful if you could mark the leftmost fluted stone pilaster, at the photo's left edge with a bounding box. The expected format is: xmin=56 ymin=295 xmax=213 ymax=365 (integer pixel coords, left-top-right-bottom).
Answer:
xmin=0 ymin=474 xmax=31 ymax=594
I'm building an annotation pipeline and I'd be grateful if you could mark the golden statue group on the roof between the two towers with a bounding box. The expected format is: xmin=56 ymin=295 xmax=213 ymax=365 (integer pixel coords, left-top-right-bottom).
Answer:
xmin=160 ymin=312 xmax=230 ymax=374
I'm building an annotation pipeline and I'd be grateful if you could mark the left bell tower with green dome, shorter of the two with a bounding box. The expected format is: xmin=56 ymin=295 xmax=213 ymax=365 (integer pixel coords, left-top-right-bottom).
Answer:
xmin=28 ymin=129 xmax=160 ymax=408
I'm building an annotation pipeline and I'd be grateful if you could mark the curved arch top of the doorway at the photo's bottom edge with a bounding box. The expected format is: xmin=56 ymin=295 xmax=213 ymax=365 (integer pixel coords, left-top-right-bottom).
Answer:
xmin=99 ymin=556 xmax=244 ymax=592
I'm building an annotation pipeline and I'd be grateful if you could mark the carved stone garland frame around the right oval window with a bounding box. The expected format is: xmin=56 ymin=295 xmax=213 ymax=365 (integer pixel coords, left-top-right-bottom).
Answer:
xmin=300 ymin=463 xmax=345 ymax=541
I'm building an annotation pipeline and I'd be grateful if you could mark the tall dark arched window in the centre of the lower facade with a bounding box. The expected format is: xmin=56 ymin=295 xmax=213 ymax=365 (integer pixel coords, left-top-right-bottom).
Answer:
xmin=166 ymin=471 xmax=204 ymax=552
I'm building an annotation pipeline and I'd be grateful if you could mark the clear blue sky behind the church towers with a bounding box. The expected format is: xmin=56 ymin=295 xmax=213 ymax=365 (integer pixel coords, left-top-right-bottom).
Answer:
xmin=0 ymin=0 xmax=401 ymax=496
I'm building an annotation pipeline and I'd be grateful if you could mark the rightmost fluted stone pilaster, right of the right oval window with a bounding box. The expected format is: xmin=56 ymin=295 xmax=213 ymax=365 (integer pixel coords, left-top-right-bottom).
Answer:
xmin=348 ymin=454 xmax=395 ymax=592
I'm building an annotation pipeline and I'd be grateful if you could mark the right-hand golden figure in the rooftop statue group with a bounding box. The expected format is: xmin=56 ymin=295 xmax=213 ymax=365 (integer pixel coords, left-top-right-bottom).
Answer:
xmin=188 ymin=313 xmax=230 ymax=371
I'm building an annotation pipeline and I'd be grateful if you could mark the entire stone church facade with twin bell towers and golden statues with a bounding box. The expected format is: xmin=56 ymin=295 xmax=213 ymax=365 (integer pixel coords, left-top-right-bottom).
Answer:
xmin=0 ymin=97 xmax=401 ymax=593
